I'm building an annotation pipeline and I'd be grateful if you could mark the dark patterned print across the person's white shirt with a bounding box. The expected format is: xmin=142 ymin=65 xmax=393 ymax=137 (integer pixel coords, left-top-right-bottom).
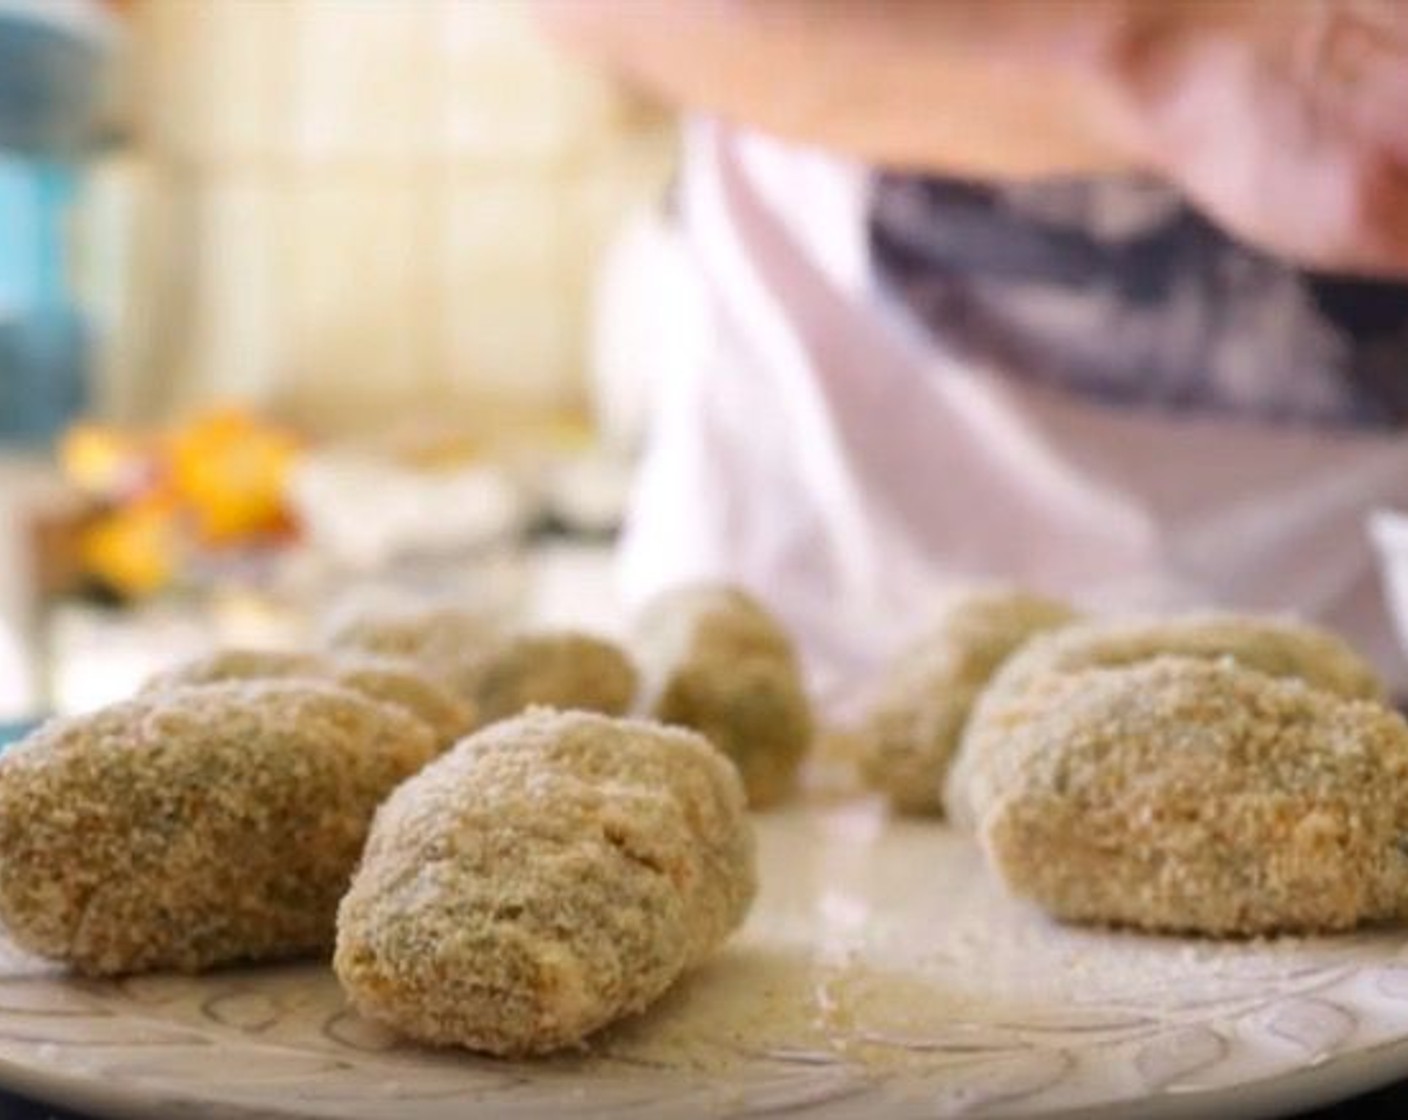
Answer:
xmin=870 ymin=176 xmax=1408 ymax=428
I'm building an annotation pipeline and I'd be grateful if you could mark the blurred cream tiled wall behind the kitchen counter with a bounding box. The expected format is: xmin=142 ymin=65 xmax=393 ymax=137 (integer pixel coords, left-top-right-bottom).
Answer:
xmin=92 ymin=0 xmax=673 ymax=430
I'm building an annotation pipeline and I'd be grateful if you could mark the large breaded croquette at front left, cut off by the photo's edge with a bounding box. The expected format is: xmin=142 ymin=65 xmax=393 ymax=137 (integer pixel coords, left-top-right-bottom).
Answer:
xmin=0 ymin=682 xmax=434 ymax=975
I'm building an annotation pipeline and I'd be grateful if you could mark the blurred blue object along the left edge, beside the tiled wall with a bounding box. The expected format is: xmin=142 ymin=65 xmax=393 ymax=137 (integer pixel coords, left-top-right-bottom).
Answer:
xmin=0 ymin=0 xmax=106 ymax=444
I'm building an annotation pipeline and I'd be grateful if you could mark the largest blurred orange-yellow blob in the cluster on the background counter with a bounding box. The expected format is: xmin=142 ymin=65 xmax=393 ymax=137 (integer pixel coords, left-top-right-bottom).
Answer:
xmin=168 ymin=409 xmax=300 ymax=544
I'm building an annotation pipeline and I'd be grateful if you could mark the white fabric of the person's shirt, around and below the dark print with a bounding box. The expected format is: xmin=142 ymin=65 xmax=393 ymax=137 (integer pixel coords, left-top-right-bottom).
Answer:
xmin=621 ymin=121 xmax=1408 ymax=711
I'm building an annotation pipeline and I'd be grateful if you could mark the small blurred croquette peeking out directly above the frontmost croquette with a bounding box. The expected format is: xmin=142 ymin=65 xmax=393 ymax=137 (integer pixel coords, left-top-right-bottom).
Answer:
xmin=459 ymin=630 xmax=639 ymax=723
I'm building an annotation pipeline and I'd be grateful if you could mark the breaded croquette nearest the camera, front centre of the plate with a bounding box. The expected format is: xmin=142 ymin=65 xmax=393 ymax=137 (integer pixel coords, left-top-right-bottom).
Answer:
xmin=334 ymin=709 xmax=756 ymax=1055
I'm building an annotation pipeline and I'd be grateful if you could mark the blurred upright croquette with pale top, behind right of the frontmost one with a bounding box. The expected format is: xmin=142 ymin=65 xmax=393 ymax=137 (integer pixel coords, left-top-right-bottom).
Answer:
xmin=634 ymin=585 xmax=815 ymax=807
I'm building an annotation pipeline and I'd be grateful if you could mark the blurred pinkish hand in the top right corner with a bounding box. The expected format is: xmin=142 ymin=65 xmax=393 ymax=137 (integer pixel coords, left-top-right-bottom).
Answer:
xmin=1117 ymin=0 xmax=1408 ymax=275
